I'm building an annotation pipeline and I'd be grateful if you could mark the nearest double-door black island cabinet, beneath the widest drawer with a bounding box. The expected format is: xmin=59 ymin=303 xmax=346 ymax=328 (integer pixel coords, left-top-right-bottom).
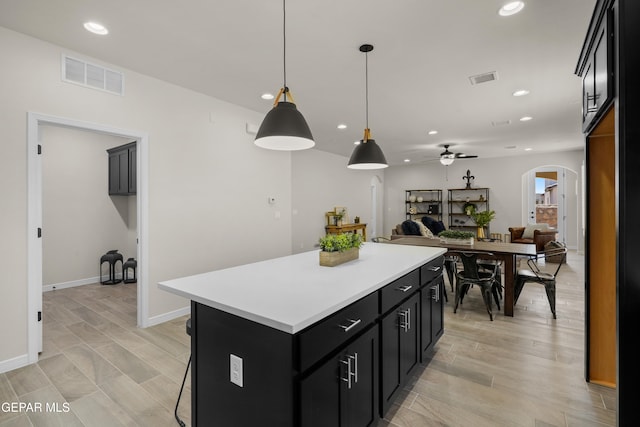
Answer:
xmin=300 ymin=326 xmax=379 ymax=427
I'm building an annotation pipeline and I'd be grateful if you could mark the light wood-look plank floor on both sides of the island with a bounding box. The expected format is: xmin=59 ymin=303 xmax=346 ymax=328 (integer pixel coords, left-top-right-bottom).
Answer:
xmin=0 ymin=253 xmax=616 ymax=427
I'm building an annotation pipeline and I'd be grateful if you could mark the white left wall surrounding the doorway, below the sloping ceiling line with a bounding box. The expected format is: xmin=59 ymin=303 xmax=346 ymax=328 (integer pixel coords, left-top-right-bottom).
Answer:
xmin=0 ymin=28 xmax=292 ymax=363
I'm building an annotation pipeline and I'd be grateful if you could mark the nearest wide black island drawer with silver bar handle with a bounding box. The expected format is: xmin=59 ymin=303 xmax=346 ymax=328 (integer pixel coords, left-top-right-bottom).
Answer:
xmin=298 ymin=292 xmax=378 ymax=372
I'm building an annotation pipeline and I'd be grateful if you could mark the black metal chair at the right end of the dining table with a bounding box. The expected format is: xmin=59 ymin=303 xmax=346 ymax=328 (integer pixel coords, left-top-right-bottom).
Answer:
xmin=513 ymin=247 xmax=567 ymax=319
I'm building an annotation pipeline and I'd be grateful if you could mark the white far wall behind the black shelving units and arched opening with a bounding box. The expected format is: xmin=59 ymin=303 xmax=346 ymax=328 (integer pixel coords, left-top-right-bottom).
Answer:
xmin=384 ymin=150 xmax=584 ymax=250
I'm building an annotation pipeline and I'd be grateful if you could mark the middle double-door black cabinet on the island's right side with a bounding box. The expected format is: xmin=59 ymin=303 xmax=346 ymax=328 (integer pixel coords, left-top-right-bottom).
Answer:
xmin=380 ymin=292 xmax=420 ymax=414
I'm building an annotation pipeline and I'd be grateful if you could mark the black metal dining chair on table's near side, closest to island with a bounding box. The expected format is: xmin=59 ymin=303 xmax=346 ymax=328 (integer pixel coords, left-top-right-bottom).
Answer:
xmin=453 ymin=252 xmax=500 ymax=321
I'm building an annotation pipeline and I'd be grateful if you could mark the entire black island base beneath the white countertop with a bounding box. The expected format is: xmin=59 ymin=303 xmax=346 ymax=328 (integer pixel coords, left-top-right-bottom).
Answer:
xmin=191 ymin=256 xmax=444 ymax=427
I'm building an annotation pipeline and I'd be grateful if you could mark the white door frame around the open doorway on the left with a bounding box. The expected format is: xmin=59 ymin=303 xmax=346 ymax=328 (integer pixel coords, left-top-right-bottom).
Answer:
xmin=27 ymin=112 xmax=149 ymax=363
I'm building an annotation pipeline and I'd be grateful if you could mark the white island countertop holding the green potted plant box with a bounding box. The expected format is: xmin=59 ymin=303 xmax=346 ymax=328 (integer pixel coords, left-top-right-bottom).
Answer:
xmin=158 ymin=243 xmax=447 ymax=334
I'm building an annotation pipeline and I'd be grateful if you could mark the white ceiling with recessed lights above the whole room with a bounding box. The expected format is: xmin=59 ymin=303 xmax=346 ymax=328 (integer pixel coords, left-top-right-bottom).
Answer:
xmin=0 ymin=0 xmax=595 ymax=165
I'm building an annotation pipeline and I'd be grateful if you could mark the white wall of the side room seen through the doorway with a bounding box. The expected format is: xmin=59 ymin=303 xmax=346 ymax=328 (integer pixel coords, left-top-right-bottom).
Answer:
xmin=40 ymin=126 xmax=136 ymax=286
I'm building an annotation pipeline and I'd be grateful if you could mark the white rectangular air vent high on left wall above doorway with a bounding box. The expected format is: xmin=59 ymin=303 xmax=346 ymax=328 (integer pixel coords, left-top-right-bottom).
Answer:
xmin=62 ymin=55 xmax=124 ymax=95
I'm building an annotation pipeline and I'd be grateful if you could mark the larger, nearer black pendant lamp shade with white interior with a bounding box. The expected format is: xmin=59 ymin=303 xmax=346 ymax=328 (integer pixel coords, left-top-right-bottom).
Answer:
xmin=254 ymin=101 xmax=315 ymax=151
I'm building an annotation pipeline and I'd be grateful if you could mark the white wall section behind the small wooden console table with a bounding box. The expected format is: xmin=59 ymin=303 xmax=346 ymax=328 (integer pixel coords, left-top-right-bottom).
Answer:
xmin=291 ymin=150 xmax=384 ymax=253
